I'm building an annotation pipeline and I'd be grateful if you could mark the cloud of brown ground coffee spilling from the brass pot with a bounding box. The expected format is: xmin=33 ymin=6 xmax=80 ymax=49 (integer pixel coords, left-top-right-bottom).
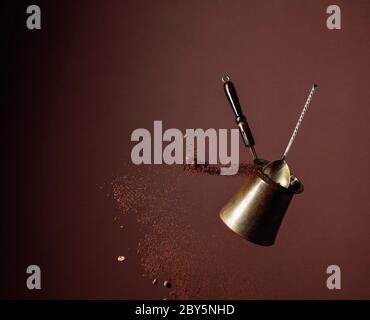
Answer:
xmin=109 ymin=164 xmax=255 ymax=299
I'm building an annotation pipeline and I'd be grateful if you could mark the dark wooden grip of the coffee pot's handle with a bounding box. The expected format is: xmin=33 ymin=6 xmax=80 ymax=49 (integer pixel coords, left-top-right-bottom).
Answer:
xmin=223 ymin=76 xmax=255 ymax=147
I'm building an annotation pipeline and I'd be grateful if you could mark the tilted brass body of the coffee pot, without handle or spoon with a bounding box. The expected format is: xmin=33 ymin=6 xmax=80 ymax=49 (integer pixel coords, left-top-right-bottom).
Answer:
xmin=220 ymin=168 xmax=303 ymax=246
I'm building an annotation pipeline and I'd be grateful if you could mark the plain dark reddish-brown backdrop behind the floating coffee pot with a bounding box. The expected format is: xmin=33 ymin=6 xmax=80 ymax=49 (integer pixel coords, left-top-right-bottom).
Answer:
xmin=0 ymin=0 xmax=370 ymax=299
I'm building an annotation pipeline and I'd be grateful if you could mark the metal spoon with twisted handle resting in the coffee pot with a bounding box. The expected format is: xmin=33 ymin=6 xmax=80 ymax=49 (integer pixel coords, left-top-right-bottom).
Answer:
xmin=262 ymin=84 xmax=317 ymax=188
